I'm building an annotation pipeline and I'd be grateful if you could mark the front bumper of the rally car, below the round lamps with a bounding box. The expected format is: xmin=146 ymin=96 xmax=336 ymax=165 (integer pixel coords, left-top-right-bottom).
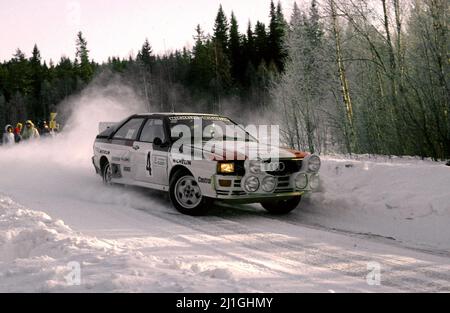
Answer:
xmin=212 ymin=173 xmax=319 ymax=203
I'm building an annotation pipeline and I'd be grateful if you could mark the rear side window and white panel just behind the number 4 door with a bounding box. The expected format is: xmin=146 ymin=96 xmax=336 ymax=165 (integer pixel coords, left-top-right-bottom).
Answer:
xmin=109 ymin=117 xmax=145 ymax=183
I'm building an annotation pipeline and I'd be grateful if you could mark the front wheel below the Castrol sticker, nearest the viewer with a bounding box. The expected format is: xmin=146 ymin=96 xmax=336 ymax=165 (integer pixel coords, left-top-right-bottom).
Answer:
xmin=169 ymin=170 xmax=212 ymax=216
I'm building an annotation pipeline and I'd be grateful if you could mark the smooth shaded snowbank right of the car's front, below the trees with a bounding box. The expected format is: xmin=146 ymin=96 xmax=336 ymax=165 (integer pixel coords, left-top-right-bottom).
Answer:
xmin=299 ymin=156 xmax=450 ymax=251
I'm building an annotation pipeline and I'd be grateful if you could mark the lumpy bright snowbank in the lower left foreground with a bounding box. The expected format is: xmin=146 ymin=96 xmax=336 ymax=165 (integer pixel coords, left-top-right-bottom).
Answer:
xmin=0 ymin=195 xmax=245 ymax=292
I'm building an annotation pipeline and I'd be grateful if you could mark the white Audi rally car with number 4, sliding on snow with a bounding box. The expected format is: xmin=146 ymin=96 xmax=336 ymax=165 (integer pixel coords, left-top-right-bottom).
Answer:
xmin=92 ymin=113 xmax=321 ymax=215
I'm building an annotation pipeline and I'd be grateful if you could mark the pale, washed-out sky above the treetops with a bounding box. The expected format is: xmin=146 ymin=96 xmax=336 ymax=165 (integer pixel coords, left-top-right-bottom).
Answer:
xmin=0 ymin=0 xmax=302 ymax=62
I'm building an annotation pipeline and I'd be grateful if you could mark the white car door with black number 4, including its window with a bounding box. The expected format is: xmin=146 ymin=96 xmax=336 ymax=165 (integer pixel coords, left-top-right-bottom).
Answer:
xmin=132 ymin=117 xmax=169 ymax=186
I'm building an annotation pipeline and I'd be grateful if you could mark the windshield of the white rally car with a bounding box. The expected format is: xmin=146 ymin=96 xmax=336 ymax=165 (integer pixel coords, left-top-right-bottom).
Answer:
xmin=169 ymin=115 xmax=258 ymax=142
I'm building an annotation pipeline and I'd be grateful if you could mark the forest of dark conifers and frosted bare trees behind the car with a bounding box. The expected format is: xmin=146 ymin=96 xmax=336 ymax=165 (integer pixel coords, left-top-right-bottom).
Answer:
xmin=0 ymin=0 xmax=450 ymax=159
